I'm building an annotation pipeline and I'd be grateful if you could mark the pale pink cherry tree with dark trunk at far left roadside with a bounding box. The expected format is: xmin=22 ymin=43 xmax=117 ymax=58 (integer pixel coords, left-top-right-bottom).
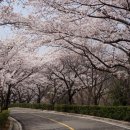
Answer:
xmin=0 ymin=37 xmax=43 ymax=109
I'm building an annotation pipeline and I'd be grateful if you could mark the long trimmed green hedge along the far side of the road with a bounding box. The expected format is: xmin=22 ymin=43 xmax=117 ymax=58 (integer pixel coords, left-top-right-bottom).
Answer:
xmin=9 ymin=103 xmax=130 ymax=121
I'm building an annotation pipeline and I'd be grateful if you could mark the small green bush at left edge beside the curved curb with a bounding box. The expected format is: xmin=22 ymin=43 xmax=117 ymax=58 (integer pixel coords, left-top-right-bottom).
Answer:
xmin=0 ymin=110 xmax=9 ymax=128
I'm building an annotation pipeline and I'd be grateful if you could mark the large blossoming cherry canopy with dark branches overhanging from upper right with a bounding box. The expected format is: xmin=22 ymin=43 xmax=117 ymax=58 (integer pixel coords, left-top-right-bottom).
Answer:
xmin=25 ymin=0 xmax=130 ymax=75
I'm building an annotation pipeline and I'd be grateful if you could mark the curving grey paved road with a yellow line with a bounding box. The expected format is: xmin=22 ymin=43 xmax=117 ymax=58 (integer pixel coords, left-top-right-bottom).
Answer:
xmin=11 ymin=108 xmax=128 ymax=130
